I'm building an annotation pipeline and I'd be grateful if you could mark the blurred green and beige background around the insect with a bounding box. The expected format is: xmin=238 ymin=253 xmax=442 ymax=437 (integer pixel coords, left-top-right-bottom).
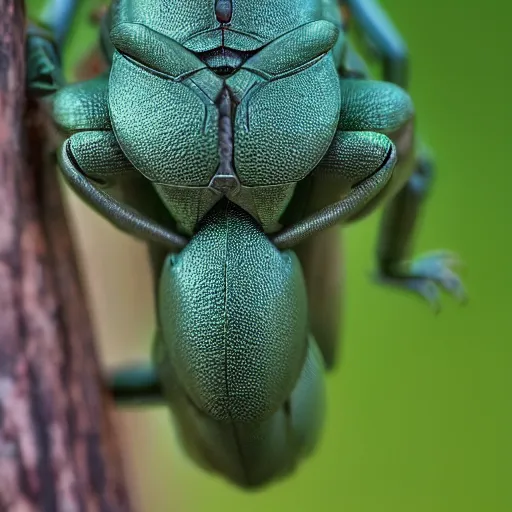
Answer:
xmin=28 ymin=0 xmax=512 ymax=512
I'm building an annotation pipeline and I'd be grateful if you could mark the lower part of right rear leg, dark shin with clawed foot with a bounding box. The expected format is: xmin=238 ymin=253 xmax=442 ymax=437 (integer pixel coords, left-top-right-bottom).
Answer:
xmin=377 ymin=155 xmax=466 ymax=311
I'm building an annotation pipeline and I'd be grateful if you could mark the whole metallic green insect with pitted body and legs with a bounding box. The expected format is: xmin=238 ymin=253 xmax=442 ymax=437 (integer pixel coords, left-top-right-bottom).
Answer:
xmin=29 ymin=0 xmax=464 ymax=488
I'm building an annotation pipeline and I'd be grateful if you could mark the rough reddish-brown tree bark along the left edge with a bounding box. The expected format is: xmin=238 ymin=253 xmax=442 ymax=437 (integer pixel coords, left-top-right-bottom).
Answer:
xmin=0 ymin=0 xmax=134 ymax=512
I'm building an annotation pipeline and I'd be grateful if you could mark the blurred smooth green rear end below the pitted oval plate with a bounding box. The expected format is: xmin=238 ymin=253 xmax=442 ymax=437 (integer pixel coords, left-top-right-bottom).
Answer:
xmin=154 ymin=337 xmax=325 ymax=489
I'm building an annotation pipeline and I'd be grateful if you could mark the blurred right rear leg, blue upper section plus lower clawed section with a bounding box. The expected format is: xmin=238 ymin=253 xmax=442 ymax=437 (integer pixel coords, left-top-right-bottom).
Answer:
xmin=340 ymin=6 xmax=465 ymax=309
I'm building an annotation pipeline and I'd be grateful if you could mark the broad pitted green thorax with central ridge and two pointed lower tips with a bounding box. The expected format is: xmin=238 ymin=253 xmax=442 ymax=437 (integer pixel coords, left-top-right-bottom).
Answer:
xmin=109 ymin=0 xmax=339 ymax=233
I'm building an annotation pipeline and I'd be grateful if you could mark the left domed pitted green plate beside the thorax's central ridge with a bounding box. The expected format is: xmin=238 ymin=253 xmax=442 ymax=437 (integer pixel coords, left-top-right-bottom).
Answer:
xmin=109 ymin=54 xmax=219 ymax=186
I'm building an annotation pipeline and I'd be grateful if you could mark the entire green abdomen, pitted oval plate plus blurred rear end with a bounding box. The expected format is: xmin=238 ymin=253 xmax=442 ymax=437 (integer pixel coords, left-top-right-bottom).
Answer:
xmin=155 ymin=202 xmax=324 ymax=488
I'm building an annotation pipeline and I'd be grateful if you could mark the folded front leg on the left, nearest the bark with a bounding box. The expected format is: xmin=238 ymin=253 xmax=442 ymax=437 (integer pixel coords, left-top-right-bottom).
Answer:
xmin=47 ymin=75 xmax=187 ymax=250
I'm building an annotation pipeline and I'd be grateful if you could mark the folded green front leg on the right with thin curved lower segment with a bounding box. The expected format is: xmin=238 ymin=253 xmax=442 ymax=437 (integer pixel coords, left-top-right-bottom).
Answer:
xmin=274 ymin=79 xmax=414 ymax=247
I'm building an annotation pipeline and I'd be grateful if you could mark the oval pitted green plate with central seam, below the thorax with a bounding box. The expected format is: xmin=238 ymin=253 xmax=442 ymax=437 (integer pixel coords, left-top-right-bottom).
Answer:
xmin=159 ymin=203 xmax=308 ymax=423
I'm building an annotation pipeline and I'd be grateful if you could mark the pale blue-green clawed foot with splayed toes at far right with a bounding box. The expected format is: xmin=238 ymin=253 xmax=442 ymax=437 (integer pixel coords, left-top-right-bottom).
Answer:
xmin=378 ymin=251 xmax=467 ymax=313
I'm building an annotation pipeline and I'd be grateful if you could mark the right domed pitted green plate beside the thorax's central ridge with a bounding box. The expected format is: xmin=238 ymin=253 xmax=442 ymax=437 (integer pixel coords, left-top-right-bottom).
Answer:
xmin=235 ymin=57 xmax=340 ymax=187
